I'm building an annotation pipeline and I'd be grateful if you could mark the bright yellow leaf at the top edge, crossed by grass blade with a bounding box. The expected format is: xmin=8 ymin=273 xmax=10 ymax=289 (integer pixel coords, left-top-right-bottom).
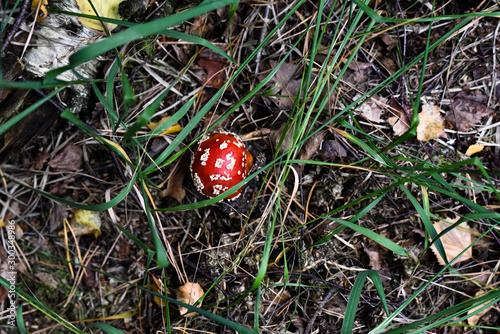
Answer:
xmin=76 ymin=0 xmax=123 ymax=31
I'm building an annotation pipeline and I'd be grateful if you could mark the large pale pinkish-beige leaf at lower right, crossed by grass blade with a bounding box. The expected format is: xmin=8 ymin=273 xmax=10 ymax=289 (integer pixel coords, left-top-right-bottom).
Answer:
xmin=431 ymin=217 xmax=472 ymax=266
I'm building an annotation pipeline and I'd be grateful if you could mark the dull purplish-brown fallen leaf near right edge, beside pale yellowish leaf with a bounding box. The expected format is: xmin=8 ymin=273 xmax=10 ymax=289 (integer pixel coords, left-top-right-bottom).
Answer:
xmin=446 ymin=91 xmax=493 ymax=132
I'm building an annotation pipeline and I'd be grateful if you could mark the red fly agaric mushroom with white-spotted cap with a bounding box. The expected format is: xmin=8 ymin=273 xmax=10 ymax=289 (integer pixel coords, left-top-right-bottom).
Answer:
xmin=191 ymin=132 xmax=253 ymax=199
